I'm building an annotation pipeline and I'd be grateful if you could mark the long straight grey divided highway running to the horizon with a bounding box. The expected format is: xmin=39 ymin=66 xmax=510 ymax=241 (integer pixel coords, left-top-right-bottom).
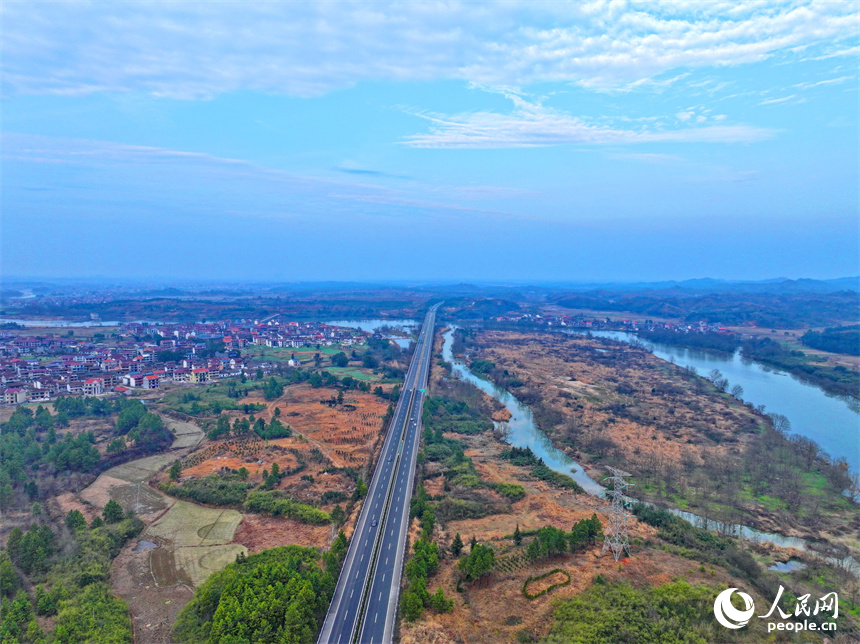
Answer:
xmin=318 ymin=304 xmax=439 ymax=644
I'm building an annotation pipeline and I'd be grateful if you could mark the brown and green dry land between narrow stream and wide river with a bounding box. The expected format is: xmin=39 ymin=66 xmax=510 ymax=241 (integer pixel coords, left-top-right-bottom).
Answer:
xmin=473 ymin=331 xmax=860 ymax=540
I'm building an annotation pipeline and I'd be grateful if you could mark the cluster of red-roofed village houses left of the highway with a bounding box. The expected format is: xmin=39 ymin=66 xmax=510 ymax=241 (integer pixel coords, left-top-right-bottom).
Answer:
xmin=0 ymin=316 xmax=364 ymax=405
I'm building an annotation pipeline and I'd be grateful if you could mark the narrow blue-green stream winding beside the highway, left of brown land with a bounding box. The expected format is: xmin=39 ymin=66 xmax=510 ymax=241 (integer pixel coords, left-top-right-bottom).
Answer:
xmin=442 ymin=327 xmax=860 ymax=576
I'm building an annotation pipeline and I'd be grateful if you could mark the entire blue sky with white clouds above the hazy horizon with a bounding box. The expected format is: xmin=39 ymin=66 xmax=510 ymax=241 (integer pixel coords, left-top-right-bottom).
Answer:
xmin=0 ymin=0 xmax=860 ymax=282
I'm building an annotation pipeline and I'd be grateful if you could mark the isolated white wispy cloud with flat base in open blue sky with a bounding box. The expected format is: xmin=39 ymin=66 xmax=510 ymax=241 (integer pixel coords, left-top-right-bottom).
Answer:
xmin=404 ymin=95 xmax=774 ymax=148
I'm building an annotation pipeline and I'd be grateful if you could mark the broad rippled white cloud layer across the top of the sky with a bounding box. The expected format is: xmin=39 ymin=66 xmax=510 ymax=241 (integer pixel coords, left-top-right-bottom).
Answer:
xmin=0 ymin=0 xmax=860 ymax=98
